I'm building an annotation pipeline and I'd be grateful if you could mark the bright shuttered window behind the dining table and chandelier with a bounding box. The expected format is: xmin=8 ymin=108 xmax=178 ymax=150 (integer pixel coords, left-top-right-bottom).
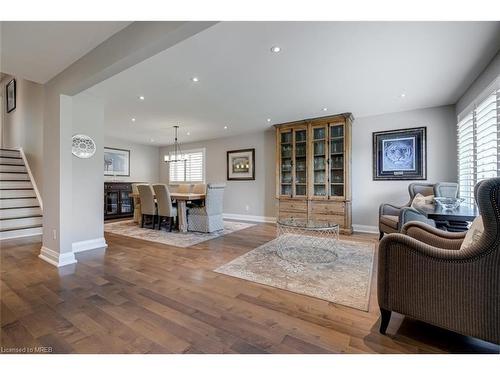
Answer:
xmin=168 ymin=148 xmax=205 ymax=183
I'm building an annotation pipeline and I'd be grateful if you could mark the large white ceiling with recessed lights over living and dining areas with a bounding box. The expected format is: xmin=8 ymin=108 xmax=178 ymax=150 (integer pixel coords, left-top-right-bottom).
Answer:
xmin=90 ymin=22 xmax=500 ymax=145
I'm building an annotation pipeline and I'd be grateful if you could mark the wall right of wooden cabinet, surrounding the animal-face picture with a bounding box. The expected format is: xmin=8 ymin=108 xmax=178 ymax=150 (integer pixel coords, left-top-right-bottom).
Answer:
xmin=352 ymin=106 xmax=457 ymax=226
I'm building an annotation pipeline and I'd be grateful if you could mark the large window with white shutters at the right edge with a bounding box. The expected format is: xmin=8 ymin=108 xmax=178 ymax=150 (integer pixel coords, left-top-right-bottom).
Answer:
xmin=457 ymin=89 xmax=500 ymax=205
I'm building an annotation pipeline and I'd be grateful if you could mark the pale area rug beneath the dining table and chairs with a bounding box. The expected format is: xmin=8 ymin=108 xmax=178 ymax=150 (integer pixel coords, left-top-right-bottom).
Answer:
xmin=104 ymin=220 xmax=255 ymax=247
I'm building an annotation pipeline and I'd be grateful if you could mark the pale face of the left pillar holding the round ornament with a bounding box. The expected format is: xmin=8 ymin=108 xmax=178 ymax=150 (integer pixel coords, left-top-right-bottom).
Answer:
xmin=72 ymin=93 xmax=104 ymax=243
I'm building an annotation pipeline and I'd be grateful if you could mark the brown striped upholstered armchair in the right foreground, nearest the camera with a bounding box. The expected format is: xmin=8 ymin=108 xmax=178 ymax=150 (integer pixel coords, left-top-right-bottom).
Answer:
xmin=378 ymin=178 xmax=500 ymax=344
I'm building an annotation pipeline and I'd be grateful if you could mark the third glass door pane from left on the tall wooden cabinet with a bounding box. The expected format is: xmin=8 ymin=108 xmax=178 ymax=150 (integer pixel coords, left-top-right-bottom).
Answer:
xmin=312 ymin=125 xmax=328 ymax=198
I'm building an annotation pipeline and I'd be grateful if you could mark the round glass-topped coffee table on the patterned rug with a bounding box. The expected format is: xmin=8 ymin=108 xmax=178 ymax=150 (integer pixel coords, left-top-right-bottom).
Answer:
xmin=276 ymin=219 xmax=340 ymax=265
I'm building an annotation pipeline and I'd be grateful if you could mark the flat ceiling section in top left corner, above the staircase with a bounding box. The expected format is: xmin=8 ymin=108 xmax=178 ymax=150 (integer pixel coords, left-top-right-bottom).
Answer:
xmin=0 ymin=21 xmax=130 ymax=83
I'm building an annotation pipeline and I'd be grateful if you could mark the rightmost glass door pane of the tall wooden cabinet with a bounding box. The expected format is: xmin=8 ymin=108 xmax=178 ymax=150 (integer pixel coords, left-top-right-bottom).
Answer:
xmin=329 ymin=124 xmax=345 ymax=197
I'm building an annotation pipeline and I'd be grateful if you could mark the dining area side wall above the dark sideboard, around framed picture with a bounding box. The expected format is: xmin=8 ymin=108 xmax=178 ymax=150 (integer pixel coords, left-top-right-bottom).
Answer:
xmin=104 ymin=136 xmax=160 ymax=183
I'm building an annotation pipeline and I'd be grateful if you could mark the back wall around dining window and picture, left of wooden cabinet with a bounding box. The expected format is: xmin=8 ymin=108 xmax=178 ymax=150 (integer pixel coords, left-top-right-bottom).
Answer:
xmin=160 ymin=130 xmax=276 ymax=217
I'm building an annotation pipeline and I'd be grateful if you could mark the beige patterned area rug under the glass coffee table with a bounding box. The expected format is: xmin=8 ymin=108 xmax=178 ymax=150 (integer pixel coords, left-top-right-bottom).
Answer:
xmin=215 ymin=234 xmax=375 ymax=311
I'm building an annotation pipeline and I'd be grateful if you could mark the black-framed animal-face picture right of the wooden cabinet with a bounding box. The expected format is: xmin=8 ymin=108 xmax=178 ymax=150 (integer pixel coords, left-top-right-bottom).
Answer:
xmin=373 ymin=127 xmax=427 ymax=181
